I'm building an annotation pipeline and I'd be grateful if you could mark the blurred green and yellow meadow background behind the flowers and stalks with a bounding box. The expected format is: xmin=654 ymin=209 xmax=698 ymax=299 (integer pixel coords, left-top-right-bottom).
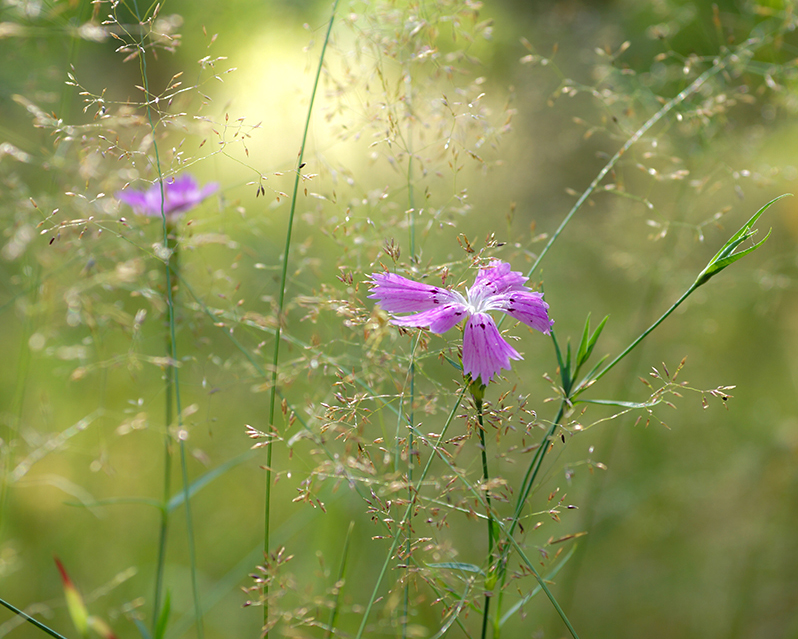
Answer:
xmin=0 ymin=0 xmax=798 ymax=638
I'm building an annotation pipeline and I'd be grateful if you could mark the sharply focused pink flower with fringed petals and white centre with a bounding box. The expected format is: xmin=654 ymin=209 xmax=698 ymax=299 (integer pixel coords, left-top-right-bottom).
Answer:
xmin=369 ymin=260 xmax=554 ymax=384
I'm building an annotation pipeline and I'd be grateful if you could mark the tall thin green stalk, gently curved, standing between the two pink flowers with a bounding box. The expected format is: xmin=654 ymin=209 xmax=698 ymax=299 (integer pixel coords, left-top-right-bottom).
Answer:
xmin=263 ymin=0 xmax=339 ymax=637
